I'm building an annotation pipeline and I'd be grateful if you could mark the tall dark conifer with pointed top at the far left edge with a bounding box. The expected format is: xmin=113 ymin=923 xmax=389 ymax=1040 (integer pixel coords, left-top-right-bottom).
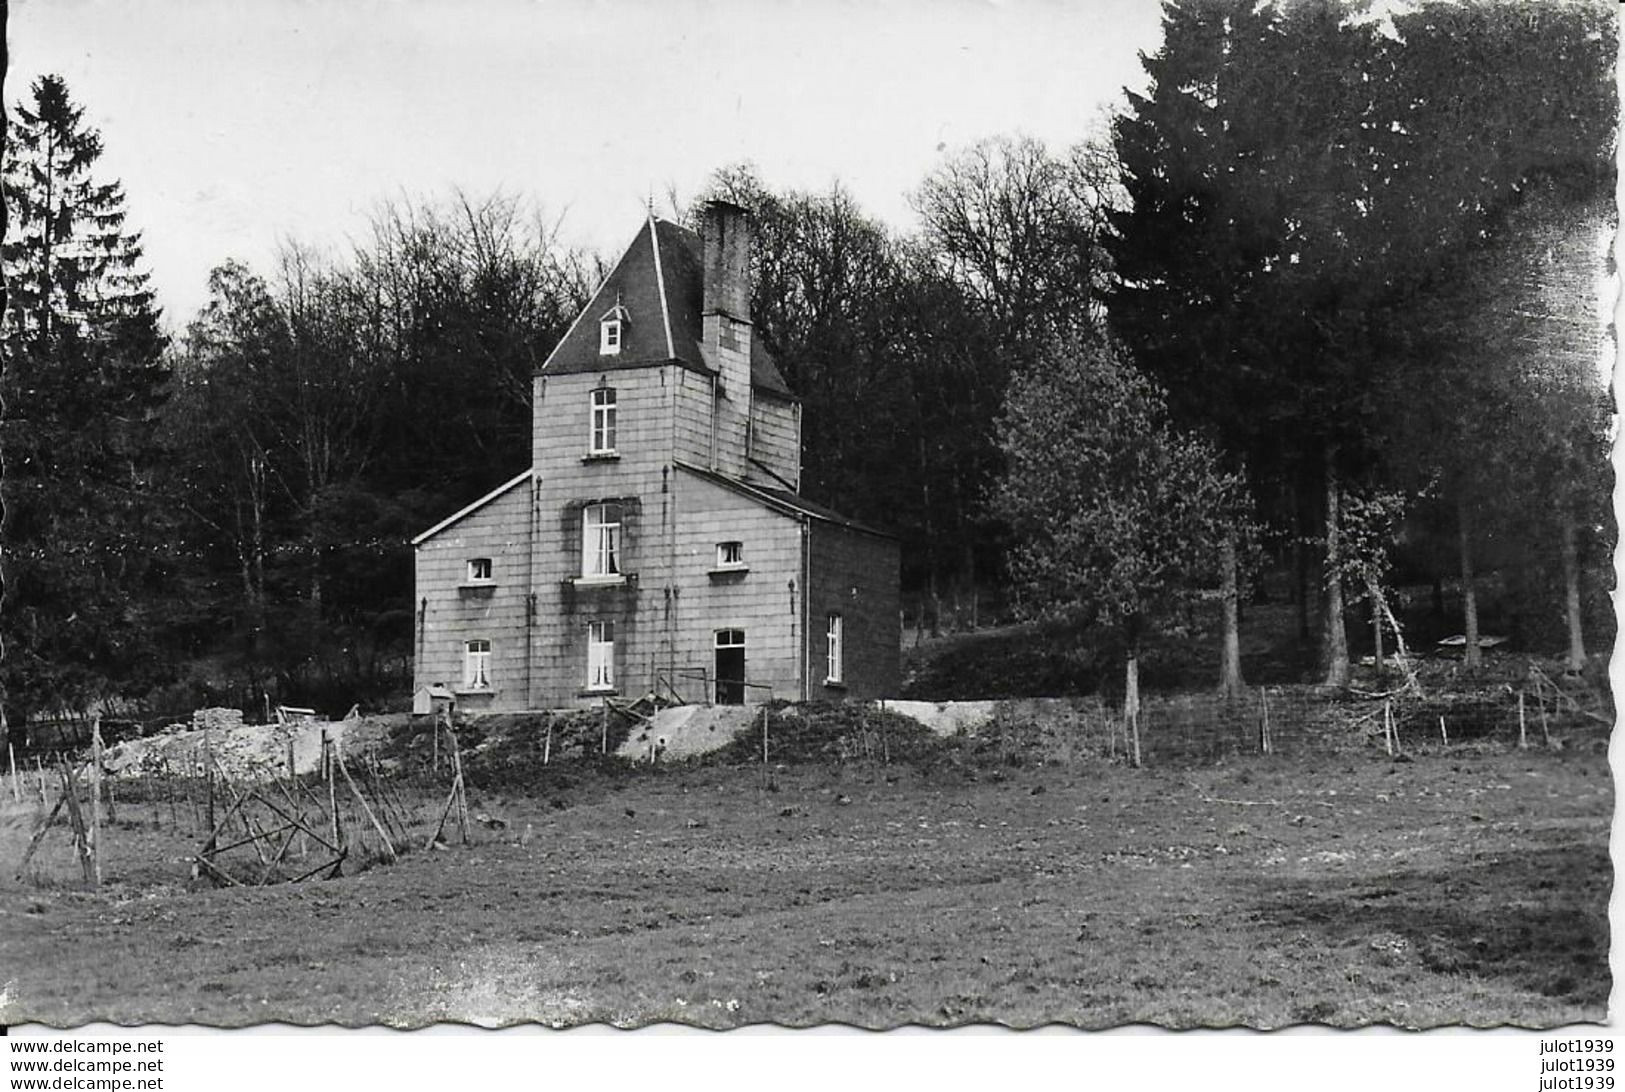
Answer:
xmin=0 ymin=76 xmax=166 ymax=722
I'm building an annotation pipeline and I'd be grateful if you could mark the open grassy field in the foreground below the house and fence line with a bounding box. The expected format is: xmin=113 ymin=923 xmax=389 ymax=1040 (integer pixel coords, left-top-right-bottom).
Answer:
xmin=0 ymin=728 xmax=1614 ymax=1027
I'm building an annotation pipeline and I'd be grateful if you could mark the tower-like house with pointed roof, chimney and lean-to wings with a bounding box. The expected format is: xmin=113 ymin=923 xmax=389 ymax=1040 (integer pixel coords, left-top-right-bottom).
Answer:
xmin=413 ymin=202 xmax=900 ymax=712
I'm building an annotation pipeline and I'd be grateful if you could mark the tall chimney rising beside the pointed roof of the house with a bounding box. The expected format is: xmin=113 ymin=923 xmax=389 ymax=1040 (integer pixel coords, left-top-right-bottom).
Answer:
xmin=700 ymin=202 xmax=752 ymax=476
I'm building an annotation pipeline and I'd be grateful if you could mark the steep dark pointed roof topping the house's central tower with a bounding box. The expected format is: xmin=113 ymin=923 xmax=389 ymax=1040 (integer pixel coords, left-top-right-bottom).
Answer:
xmin=541 ymin=216 xmax=795 ymax=398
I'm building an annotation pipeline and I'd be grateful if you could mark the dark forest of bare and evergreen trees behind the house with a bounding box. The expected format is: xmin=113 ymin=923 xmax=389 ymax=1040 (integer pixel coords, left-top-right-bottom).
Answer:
xmin=0 ymin=0 xmax=1617 ymax=734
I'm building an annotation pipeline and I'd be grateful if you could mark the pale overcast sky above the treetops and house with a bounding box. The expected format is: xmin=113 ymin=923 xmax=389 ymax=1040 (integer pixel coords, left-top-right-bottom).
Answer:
xmin=5 ymin=0 xmax=1160 ymax=327
